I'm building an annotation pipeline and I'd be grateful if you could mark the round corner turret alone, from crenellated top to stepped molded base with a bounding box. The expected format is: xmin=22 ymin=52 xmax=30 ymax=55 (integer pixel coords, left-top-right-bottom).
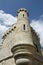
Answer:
xmin=11 ymin=8 xmax=36 ymax=65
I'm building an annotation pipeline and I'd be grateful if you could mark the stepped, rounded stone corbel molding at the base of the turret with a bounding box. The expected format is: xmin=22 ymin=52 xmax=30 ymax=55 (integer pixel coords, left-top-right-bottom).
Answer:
xmin=11 ymin=44 xmax=35 ymax=65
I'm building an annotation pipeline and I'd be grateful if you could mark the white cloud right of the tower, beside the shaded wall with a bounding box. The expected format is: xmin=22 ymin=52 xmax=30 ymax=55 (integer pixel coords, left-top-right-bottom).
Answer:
xmin=31 ymin=15 xmax=43 ymax=46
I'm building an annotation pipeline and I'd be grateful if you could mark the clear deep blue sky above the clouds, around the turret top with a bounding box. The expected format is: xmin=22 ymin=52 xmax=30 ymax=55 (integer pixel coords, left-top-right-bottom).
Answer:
xmin=0 ymin=0 xmax=43 ymax=19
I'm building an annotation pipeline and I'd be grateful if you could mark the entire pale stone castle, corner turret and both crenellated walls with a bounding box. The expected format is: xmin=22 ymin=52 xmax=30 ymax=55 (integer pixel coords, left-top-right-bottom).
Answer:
xmin=0 ymin=8 xmax=43 ymax=65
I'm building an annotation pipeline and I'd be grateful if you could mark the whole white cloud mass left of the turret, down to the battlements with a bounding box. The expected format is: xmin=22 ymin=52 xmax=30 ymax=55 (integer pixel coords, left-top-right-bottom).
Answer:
xmin=0 ymin=10 xmax=17 ymax=41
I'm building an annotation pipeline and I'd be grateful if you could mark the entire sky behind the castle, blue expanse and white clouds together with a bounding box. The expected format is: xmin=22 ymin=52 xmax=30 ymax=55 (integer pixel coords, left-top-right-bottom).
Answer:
xmin=0 ymin=0 xmax=43 ymax=46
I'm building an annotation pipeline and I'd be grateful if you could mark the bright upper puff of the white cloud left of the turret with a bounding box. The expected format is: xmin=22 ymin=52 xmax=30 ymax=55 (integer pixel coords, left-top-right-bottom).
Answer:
xmin=0 ymin=10 xmax=17 ymax=25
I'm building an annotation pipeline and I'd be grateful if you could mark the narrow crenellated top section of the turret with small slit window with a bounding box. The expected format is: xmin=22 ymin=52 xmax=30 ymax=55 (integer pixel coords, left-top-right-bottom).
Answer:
xmin=18 ymin=8 xmax=29 ymax=20
